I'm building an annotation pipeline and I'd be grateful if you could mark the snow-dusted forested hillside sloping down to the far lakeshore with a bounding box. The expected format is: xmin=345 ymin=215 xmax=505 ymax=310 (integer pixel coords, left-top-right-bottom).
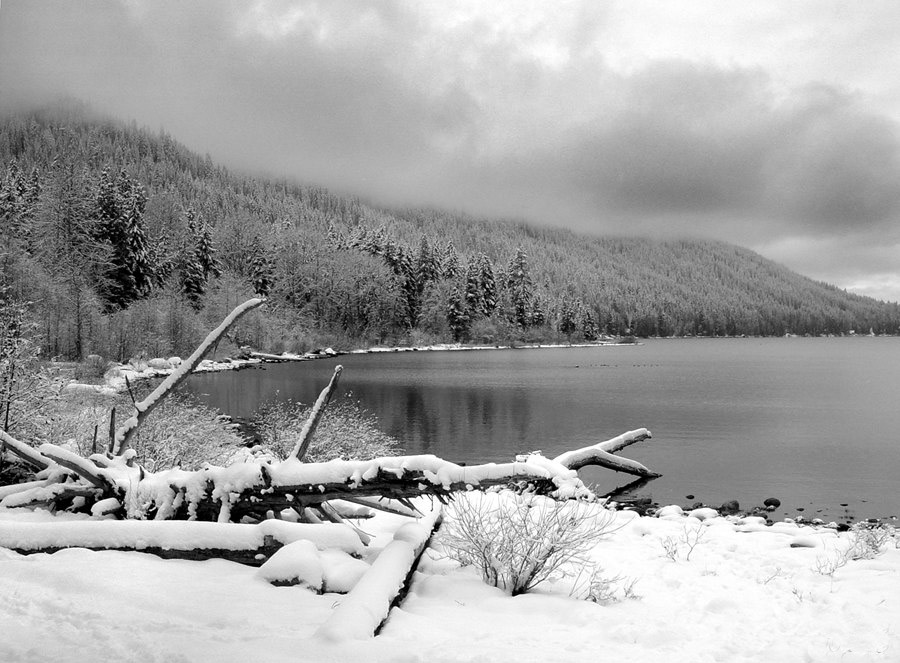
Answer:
xmin=0 ymin=104 xmax=900 ymax=359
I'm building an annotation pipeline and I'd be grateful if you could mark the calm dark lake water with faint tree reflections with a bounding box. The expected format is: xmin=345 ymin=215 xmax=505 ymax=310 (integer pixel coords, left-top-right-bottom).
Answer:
xmin=188 ymin=338 xmax=900 ymax=520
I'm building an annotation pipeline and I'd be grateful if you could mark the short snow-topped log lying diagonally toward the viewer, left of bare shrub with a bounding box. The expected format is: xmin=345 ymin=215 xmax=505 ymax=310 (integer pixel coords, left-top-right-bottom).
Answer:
xmin=316 ymin=509 xmax=440 ymax=642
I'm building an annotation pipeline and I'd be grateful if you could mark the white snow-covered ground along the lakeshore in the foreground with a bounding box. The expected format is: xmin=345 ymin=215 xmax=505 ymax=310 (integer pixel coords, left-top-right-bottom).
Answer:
xmin=0 ymin=508 xmax=900 ymax=663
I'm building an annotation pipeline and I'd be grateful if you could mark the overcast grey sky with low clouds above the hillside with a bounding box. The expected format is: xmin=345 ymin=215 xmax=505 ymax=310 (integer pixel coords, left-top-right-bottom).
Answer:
xmin=0 ymin=0 xmax=900 ymax=300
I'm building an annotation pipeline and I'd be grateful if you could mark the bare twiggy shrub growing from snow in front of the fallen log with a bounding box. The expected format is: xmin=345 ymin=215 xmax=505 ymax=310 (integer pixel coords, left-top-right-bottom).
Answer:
xmin=439 ymin=491 xmax=614 ymax=596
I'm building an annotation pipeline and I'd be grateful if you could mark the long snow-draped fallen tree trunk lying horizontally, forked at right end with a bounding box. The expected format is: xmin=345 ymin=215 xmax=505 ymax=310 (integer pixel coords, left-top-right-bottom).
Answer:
xmin=0 ymin=429 xmax=658 ymax=522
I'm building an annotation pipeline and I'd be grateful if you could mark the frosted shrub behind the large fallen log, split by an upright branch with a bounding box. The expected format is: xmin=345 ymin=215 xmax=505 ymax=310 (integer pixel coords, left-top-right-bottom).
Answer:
xmin=252 ymin=394 xmax=400 ymax=463
